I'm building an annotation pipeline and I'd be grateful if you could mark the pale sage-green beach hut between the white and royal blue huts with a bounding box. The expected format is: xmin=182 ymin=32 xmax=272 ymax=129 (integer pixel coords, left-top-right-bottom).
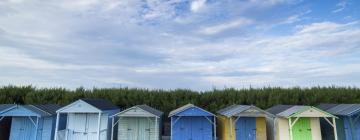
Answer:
xmin=111 ymin=105 xmax=163 ymax=140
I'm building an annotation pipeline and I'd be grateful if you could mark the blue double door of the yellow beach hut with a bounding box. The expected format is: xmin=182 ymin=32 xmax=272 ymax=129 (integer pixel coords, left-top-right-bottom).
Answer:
xmin=235 ymin=117 xmax=256 ymax=140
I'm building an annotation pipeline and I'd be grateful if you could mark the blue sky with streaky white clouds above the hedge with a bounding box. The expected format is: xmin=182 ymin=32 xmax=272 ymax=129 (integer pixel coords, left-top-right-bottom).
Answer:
xmin=0 ymin=0 xmax=360 ymax=90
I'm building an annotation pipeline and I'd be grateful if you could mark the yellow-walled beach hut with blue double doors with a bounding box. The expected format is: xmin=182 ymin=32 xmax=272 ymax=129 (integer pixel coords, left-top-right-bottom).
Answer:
xmin=217 ymin=105 xmax=274 ymax=140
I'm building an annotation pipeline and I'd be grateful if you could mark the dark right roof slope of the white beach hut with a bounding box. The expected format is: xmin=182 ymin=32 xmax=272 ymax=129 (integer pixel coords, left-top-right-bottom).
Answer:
xmin=80 ymin=98 xmax=119 ymax=111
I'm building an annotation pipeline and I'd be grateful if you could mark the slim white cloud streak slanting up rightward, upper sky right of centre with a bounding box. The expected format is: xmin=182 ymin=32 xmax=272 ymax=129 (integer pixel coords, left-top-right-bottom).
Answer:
xmin=199 ymin=18 xmax=253 ymax=35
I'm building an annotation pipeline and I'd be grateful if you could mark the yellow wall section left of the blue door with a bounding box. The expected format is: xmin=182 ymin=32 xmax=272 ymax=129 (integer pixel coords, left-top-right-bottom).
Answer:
xmin=217 ymin=115 xmax=236 ymax=140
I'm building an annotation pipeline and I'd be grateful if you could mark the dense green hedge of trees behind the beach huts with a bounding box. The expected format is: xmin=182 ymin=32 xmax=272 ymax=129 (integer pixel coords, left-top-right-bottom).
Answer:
xmin=0 ymin=86 xmax=360 ymax=115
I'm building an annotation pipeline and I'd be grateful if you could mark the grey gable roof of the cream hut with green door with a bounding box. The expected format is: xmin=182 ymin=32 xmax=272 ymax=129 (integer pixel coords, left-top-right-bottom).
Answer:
xmin=266 ymin=105 xmax=336 ymax=118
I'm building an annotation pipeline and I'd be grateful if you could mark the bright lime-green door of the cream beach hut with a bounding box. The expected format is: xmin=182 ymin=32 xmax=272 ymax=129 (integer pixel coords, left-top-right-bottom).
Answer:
xmin=292 ymin=118 xmax=312 ymax=140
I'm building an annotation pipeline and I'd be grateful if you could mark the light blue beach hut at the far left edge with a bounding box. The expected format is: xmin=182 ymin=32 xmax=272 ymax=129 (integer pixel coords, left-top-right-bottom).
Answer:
xmin=0 ymin=104 xmax=60 ymax=140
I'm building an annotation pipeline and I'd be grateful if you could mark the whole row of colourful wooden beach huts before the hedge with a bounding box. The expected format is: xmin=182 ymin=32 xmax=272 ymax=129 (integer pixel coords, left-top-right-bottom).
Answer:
xmin=0 ymin=99 xmax=360 ymax=140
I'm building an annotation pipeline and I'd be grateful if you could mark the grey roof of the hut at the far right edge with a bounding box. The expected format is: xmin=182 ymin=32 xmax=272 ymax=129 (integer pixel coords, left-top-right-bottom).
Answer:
xmin=318 ymin=104 xmax=360 ymax=116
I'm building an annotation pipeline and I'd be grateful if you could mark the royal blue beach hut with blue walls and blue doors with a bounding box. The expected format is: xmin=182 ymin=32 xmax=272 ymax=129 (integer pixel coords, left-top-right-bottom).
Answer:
xmin=169 ymin=104 xmax=216 ymax=140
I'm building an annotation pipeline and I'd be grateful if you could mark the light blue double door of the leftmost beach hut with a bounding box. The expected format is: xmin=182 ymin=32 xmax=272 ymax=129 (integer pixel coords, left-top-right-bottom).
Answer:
xmin=10 ymin=117 xmax=35 ymax=140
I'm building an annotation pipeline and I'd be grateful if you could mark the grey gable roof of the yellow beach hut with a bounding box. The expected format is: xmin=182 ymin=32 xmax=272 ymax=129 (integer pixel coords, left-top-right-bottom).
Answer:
xmin=217 ymin=105 xmax=274 ymax=117
